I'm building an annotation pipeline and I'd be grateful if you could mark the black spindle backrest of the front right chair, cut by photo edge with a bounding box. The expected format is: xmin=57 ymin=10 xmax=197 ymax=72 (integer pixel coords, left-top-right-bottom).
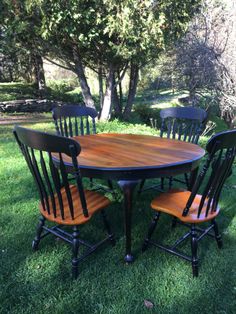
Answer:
xmin=183 ymin=130 xmax=236 ymax=217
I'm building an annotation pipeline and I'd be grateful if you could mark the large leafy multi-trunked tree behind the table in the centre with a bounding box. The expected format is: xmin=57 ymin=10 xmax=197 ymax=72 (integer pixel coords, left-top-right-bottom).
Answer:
xmin=28 ymin=0 xmax=200 ymax=119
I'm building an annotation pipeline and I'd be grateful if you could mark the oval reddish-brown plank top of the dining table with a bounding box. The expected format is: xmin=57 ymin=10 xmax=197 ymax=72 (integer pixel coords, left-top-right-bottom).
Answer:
xmin=59 ymin=133 xmax=204 ymax=176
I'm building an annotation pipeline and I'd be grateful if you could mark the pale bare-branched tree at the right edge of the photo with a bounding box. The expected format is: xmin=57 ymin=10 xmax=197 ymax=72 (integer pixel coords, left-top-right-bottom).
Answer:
xmin=163 ymin=0 xmax=236 ymax=127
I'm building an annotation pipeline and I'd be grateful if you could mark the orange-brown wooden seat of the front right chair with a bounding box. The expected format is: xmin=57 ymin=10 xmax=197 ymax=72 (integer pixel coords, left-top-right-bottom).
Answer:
xmin=151 ymin=189 xmax=220 ymax=223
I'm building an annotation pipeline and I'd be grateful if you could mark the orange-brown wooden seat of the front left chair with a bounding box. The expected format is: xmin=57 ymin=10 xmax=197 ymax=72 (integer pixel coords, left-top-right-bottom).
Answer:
xmin=39 ymin=185 xmax=111 ymax=225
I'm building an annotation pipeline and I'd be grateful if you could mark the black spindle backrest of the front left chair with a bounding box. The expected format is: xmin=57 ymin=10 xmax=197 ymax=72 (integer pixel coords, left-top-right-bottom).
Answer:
xmin=13 ymin=126 xmax=88 ymax=219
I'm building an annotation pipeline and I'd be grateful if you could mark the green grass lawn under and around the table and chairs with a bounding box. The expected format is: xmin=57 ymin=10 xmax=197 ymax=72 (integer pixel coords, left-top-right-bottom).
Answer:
xmin=0 ymin=120 xmax=236 ymax=314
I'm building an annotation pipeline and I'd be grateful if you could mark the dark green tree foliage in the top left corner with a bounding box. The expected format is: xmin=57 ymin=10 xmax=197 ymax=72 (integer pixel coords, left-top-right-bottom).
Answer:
xmin=0 ymin=0 xmax=46 ymax=96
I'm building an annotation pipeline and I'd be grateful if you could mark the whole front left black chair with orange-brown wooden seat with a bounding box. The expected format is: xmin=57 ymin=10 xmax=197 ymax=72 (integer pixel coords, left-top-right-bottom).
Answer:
xmin=14 ymin=126 xmax=114 ymax=278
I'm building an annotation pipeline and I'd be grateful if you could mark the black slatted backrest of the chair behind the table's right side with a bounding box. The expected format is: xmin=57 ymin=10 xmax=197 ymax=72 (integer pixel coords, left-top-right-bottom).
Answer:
xmin=160 ymin=107 xmax=207 ymax=144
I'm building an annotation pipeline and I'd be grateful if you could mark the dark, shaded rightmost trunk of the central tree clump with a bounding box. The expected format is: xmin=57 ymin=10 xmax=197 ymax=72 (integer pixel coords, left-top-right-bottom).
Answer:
xmin=123 ymin=62 xmax=139 ymax=120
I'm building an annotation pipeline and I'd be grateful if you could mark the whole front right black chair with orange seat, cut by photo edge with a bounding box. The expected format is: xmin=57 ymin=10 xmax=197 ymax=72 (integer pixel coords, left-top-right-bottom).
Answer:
xmin=142 ymin=130 xmax=236 ymax=276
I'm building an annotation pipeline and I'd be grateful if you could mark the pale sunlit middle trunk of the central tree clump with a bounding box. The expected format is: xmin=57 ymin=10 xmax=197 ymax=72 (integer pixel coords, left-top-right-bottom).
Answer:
xmin=100 ymin=64 xmax=114 ymax=120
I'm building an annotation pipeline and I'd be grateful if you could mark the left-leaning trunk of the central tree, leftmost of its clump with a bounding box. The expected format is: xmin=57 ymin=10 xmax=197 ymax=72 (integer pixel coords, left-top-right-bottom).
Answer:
xmin=73 ymin=49 xmax=95 ymax=109
